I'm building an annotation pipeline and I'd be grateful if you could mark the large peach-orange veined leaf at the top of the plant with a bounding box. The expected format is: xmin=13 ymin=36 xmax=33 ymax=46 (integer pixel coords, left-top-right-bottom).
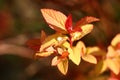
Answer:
xmin=41 ymin=9 xmax=67 ymax=32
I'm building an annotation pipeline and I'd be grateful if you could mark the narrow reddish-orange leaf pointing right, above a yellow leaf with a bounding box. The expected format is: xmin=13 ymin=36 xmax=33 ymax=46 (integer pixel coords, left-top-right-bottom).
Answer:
xmin=75 ymin=16 xmax=99 ymax=27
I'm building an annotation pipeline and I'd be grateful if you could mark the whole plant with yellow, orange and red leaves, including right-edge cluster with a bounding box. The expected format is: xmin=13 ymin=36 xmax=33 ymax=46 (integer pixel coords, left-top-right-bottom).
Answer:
xmin=27 ymin=9 xmax=120 ymax=75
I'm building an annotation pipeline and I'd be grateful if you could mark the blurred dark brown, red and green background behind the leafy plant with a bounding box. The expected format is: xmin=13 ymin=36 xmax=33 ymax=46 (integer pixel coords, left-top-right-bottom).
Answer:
xmin=0 ymin=0 xmax=120 ymax=80
